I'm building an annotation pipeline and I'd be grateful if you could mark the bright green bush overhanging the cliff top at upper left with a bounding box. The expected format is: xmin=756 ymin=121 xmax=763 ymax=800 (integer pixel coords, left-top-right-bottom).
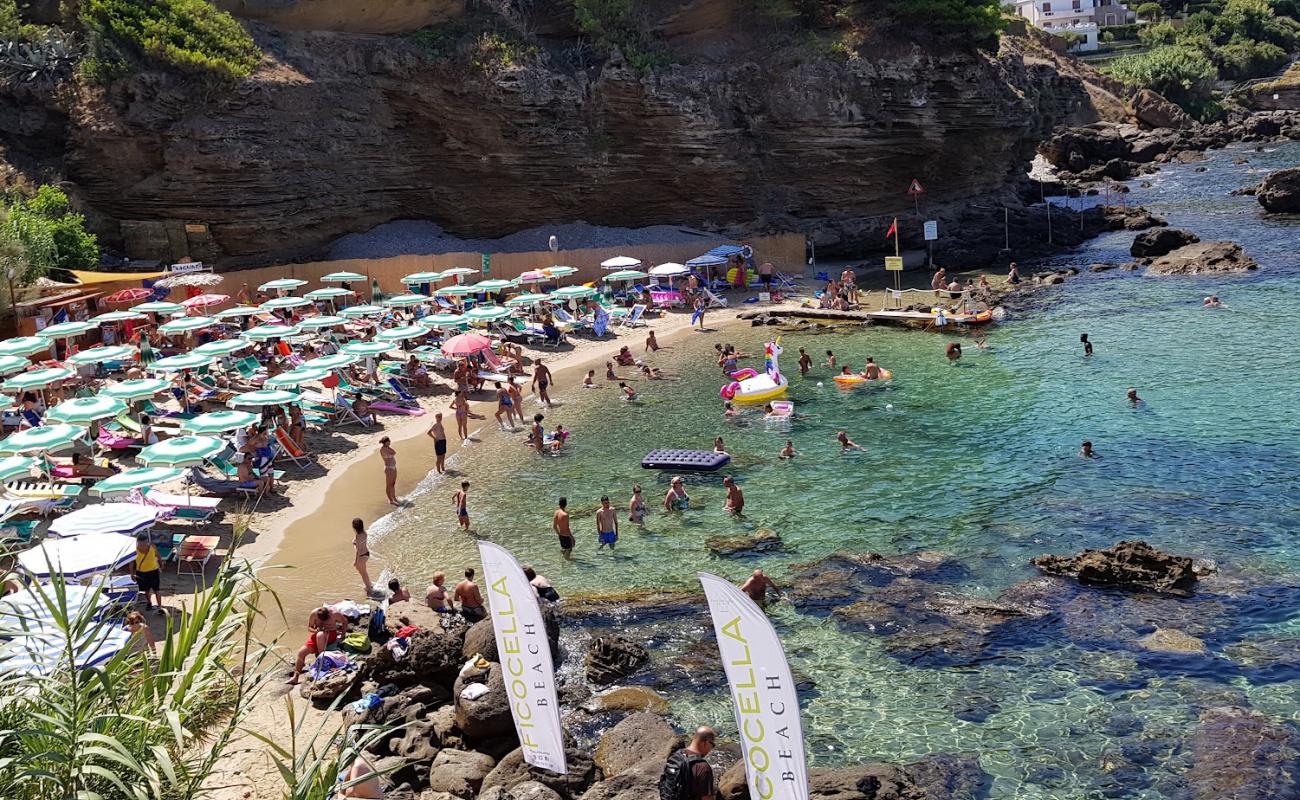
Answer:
xmin=81 ymin=0 xmax=261 ymax=81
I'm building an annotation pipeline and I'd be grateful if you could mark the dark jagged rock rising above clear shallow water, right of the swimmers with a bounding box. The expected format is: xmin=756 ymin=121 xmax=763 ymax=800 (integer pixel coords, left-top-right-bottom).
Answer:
xmin=1031 ymin=541 xmax=1197 ymax=596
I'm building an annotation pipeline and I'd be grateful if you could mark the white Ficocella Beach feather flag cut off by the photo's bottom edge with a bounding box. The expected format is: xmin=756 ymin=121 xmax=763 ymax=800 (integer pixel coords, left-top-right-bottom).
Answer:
xmin=698 ymin=572 xmax=809 ymax=800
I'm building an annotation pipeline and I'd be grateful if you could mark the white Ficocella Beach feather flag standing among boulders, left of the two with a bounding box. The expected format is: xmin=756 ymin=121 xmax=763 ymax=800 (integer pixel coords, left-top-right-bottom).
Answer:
xmin=478 ymin=541 xmax=568 ymax=775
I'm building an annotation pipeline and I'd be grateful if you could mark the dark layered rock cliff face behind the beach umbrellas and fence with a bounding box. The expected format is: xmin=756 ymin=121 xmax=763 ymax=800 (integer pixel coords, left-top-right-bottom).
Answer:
xmin=0 ymin=7 xmax=1118 ymax=263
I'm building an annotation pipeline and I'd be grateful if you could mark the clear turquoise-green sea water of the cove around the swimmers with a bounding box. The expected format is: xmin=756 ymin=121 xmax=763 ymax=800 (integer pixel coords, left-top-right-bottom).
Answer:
xmin=376 ymin=144 xmax=1300 ymax=799
